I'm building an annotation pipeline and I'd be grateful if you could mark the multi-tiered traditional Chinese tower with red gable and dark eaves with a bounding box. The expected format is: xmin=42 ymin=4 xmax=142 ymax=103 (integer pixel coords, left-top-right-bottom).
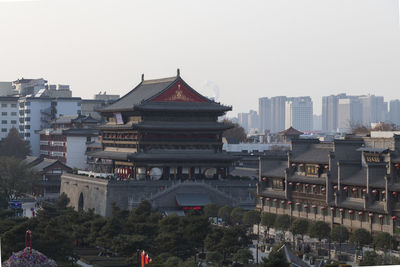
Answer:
xmin=91 ymin=69 xmax=232 ymax=180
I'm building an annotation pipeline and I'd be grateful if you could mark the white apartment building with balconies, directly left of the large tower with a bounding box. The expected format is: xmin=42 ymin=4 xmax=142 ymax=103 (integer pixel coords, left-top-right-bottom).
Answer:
xmin=18 ymin=95 xmax=81 ymax=157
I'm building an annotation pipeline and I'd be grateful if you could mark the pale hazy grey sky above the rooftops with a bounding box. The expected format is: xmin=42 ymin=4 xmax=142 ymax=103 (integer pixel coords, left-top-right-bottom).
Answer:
xmin=0 ymin=0 xmax=400 ymax=115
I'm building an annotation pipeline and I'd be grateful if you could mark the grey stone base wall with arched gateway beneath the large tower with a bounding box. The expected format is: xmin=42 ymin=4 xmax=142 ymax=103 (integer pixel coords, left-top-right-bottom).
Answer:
xmin=60 ymin=173 xmax=256 ymax=216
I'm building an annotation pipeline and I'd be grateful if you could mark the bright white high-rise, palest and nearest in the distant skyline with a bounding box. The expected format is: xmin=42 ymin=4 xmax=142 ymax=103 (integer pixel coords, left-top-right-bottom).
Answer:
xmin=285 ymin=96 xmax=313 ymax=132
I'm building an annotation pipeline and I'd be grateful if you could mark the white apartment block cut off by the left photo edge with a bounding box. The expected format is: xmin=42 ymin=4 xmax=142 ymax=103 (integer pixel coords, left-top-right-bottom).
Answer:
xmin=0 ymin=96 xmax=18 ymax=140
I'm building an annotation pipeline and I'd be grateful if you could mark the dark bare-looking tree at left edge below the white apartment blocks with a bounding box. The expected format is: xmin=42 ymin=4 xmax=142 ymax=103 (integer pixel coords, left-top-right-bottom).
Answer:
xmin=0 ymin=127 xmax=31 ymax=160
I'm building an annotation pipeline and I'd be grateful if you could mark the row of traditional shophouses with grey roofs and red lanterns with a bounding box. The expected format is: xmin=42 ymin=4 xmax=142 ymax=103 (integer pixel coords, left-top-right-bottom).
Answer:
xmin=257 ymin=131 xmax=400 ymax=234
